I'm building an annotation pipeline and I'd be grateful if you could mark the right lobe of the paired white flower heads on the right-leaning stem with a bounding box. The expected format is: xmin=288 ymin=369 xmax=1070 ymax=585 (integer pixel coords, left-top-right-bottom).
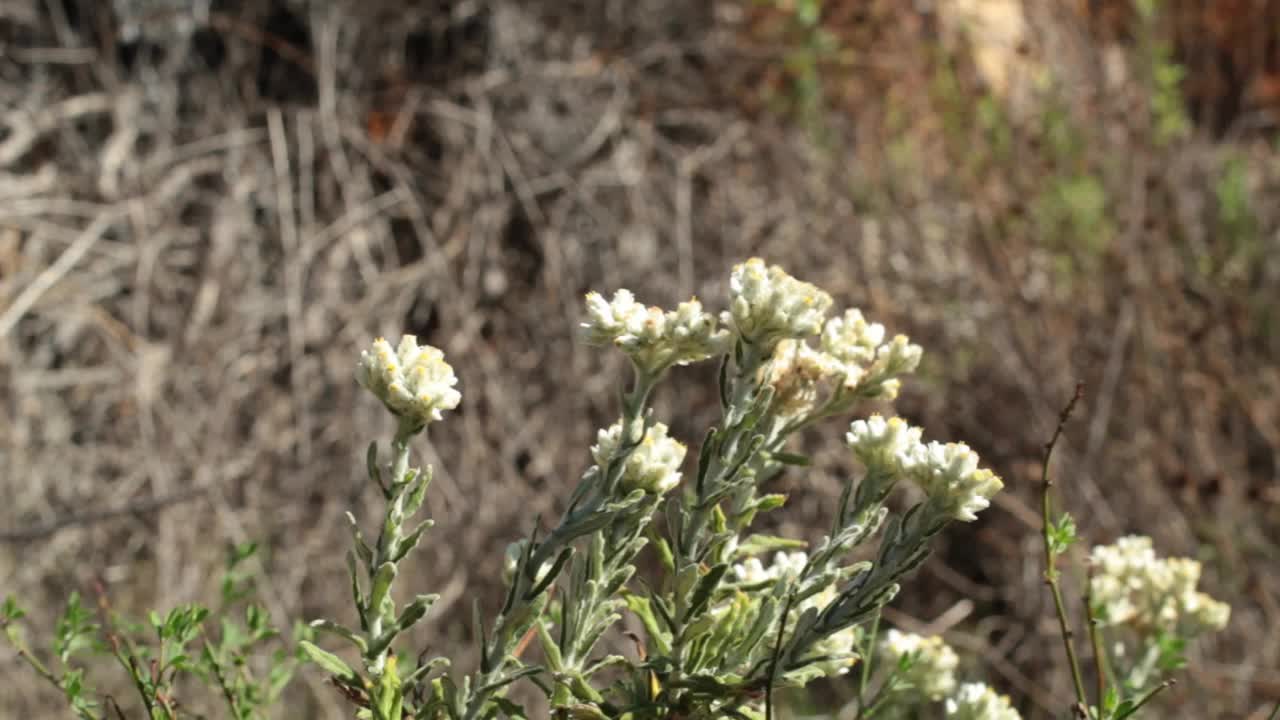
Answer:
xmin=899 ymin=442 xmax=1005 ymax=523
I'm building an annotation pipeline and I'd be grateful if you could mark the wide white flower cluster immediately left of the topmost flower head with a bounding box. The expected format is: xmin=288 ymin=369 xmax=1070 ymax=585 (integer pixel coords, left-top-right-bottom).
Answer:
xmin=581 ymin=290 xmax=731 ymax=374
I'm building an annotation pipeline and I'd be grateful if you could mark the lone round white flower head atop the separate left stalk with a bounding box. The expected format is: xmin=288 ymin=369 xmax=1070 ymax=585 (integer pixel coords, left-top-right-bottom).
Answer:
xmin=356 ymin=334 xmax=462 ymax=428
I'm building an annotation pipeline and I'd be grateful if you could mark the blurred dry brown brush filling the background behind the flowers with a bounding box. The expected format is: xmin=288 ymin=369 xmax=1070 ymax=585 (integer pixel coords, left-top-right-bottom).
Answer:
xmin=0 ymin=0 xmax=1280 ymax=717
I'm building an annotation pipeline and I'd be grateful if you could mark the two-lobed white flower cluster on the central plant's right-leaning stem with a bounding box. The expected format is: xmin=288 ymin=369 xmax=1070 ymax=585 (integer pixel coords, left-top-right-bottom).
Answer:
xmin=845 ymin=415 xmax=1005 ymax=523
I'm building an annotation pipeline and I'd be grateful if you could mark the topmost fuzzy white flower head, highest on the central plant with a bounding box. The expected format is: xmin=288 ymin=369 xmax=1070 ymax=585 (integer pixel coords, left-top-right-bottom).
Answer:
xmin=721 ymin=258 xmax=831 ymax=350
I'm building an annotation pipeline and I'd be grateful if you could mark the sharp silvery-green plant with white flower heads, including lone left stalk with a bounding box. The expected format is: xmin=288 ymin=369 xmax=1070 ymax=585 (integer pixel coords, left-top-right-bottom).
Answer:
xmin=305 ymin=259 xmax=1018 ymax=720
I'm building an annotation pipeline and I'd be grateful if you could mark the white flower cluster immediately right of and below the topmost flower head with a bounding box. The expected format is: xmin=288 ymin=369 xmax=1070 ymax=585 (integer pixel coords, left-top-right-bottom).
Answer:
xmin=820 ymin=309 xmax=923 ymax=400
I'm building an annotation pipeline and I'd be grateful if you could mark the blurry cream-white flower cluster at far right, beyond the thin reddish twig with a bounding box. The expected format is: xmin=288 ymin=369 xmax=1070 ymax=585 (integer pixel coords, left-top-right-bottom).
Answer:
xmin=1091 ymin=536 xmax=1231 ymax=634
